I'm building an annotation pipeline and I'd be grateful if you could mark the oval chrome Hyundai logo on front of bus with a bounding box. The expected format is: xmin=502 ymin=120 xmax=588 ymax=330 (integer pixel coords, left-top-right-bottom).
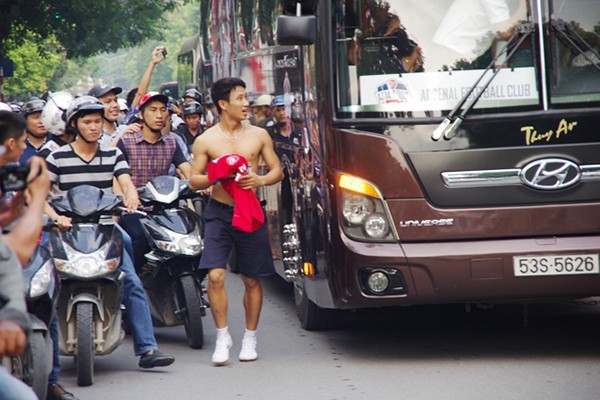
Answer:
xmin=519 ymin=158 xmax=581 ymax=190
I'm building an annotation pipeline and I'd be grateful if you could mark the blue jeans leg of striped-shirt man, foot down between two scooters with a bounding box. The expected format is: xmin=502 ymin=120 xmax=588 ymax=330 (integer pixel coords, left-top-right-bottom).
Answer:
xmin=115 ymin=224 xmax=158 ymax=356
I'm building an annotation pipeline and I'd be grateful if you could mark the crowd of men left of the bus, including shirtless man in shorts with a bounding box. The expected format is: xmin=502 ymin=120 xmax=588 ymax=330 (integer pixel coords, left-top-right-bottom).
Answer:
xmin=0 ymin=47 xmax=300 ymax=400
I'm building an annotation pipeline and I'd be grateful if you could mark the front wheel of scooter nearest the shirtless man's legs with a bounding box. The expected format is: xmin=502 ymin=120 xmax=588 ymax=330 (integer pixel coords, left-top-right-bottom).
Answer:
xmin=180 ymin=275 xmax=204 ymax=349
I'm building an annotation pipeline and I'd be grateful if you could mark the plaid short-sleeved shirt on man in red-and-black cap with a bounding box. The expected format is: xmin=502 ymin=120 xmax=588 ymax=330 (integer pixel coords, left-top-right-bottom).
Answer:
xmin=117 ymin=132 xmax=188 ymax=188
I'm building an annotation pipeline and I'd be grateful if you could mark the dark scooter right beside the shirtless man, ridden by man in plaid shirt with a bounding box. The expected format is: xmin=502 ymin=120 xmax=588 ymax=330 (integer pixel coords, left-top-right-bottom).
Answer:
xmin=138 ymin=176 xmax=208 ymax=349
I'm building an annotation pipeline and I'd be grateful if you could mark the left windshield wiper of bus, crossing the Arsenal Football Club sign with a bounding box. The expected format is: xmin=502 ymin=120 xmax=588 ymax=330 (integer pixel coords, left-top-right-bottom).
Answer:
xmin=431 ymin=22 xmax=533 ymax=141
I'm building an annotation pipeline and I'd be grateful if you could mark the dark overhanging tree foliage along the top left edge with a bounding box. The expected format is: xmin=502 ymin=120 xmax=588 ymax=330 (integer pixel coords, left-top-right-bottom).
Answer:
xmin=0 ymin=0 xmax=178 ymax=58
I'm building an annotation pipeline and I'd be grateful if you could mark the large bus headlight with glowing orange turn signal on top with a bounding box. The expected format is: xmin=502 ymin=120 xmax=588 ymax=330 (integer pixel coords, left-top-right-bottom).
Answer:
xmin=339 ymin=174 xmax=396 ymax=242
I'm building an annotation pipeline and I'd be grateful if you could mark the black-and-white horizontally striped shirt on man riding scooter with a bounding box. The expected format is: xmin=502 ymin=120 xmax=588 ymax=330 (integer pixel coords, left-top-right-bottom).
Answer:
xmin=46 ymin=144 xmax=131 ymax=194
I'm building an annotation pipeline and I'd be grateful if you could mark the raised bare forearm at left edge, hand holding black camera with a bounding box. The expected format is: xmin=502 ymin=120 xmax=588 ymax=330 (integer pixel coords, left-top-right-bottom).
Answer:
xmin=4 ymin=156 xmax=50 ymax=265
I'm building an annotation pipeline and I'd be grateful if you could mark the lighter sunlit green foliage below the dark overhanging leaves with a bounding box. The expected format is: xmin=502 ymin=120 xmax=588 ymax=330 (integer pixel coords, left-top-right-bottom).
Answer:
xmin=4 ymin=1 xmax=200 ymax=101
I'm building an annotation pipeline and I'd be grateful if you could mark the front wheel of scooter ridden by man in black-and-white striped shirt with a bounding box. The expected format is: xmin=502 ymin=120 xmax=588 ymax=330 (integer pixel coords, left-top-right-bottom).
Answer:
xmin=76 ymin=303 xmax=94 ymax=386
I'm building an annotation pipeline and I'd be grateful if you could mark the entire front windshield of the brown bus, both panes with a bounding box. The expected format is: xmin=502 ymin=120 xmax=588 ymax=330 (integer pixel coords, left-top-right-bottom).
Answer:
xmin=333 ymin=0 xmax=600 ymax=118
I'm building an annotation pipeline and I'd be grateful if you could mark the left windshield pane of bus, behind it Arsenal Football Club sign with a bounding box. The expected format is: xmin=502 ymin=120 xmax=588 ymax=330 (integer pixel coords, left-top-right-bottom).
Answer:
xmin=335 ymin=0 xmax=541 ymax=118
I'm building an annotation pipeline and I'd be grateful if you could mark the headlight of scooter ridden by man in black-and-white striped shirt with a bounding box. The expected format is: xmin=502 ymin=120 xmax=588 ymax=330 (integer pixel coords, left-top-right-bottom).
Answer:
xmin=54 ymin=243 xmax=121 ymax=278
